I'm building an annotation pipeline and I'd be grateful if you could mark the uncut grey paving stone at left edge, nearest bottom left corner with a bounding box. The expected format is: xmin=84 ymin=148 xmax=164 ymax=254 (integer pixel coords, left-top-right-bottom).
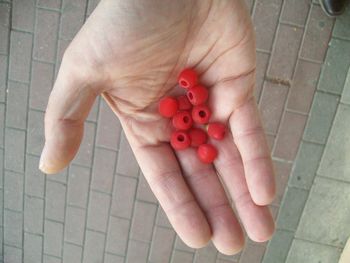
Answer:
xmin=3 ymin=210 xmax=23 ymax=248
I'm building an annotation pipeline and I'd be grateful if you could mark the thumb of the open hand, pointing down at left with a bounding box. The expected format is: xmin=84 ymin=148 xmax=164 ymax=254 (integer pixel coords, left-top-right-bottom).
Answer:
xmin=39 ymin=56 xmax=97 ymax=174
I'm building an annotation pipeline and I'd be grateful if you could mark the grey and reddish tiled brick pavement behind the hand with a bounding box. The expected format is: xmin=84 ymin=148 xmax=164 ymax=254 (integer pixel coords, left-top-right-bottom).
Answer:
xmin=0 ymin=0 xmax=350 ymax=263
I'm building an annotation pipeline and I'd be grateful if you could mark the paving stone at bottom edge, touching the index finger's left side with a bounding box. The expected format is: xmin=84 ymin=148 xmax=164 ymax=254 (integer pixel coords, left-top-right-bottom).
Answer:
xmin=149 ymin=226 xmax=175 ymax=263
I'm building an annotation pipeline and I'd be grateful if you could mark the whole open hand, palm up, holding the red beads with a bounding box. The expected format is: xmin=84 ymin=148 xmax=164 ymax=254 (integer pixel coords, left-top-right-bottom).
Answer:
xmin=40 ymin=0 xmax=275 ymax=254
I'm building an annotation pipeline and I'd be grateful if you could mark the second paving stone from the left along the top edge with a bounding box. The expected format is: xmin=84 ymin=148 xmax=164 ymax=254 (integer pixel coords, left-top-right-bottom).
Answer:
xmin=12 ymin=0 xmax=36 ymax=32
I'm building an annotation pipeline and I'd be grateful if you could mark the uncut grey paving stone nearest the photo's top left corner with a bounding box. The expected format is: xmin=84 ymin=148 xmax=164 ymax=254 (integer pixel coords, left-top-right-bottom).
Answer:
xmin=9 ymin=30 xmax=33 ymax=82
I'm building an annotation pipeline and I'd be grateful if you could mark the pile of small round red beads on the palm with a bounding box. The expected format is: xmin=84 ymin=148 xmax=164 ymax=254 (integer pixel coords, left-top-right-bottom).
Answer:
xmin=158 ymin=68 xmax=226 ymax=163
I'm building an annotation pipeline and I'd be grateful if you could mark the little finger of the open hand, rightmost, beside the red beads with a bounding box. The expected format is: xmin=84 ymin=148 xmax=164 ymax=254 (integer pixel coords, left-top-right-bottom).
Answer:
xmin=229 ymin=97 xmax=276 ymax=205
